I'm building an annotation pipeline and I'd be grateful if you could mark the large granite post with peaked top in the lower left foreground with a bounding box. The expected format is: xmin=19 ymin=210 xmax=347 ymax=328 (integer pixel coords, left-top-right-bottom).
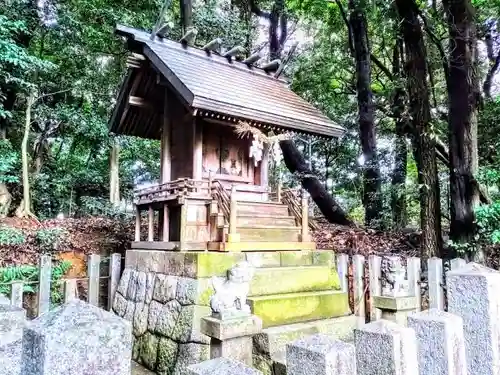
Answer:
xmin=21 ymin=300 xmax=132 ymax=375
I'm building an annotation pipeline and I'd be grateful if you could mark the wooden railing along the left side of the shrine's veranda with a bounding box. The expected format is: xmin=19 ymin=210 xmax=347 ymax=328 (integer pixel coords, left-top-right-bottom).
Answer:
xmin=134 ymin=178 xmax=209 ymax=204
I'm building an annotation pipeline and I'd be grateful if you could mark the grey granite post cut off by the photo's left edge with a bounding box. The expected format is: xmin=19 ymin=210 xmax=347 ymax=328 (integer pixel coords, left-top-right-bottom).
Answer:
xmin=0 ymin=304 xmax=26 ymax=375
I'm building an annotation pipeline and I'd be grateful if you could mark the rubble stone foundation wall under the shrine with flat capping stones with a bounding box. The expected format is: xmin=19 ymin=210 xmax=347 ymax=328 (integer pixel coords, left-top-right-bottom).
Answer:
xmin=113 ymin=250 xmax=342 ymax=375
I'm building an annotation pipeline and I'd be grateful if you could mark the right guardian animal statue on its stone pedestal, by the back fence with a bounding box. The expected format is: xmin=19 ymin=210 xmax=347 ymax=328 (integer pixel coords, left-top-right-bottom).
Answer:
xmin=373 ymin=257 xmax=419 ymax=325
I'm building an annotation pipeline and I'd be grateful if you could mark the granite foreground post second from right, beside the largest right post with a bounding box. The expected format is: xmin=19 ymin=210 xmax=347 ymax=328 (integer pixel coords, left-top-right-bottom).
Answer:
xmin=408 ymin=309 xmax=467 ymax=375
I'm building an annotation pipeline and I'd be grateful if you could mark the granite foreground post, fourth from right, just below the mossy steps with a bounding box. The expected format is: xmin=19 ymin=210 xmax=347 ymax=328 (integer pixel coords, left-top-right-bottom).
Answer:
xmin=286 ymin=334 xmax=356 ymax=375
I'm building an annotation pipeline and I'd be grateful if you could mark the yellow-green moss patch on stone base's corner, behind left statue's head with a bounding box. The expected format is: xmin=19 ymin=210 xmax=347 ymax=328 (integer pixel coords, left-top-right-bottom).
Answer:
xmin=186 ymin=252 xmax=245 ymax=278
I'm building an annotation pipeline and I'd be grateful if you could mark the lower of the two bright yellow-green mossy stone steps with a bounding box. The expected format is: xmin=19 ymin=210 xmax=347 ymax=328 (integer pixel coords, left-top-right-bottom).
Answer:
xmin=247 ymin=291 xmax=350 ymax=328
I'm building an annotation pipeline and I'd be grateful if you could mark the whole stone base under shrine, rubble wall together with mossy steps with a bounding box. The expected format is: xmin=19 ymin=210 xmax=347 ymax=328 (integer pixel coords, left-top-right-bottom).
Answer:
xmin=113 ymin=249 xmax=350 ymax=375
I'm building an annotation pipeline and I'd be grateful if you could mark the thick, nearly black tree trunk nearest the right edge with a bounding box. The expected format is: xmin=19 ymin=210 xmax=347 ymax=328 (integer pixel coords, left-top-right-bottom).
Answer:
xmin=444 ymin=0 xmax=484 ymax=261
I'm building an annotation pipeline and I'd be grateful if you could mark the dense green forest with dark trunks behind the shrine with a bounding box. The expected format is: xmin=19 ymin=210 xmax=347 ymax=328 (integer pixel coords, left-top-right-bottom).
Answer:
xmin=0 ymin=0 xmax=500 ymax=262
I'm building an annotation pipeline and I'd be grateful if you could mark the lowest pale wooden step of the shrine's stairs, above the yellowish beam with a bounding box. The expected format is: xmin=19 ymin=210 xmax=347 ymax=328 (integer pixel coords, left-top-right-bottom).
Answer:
xmin=230 ymin=225 xmax=301 ymax=242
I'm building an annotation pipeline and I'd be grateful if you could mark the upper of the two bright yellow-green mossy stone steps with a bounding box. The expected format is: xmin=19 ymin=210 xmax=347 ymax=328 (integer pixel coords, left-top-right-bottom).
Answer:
xmin=249 ymin=266 xmax=340 ymax=296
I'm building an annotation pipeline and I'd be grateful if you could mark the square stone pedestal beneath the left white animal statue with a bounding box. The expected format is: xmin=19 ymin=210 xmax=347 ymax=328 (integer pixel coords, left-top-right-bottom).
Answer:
xmin=201 ymin=315 xmax=262 ymax=366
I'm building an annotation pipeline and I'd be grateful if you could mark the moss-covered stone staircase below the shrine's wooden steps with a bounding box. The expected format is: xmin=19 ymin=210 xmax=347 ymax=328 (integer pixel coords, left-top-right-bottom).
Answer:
xmin=246 ymin=251 xmax=357 ymax=375
